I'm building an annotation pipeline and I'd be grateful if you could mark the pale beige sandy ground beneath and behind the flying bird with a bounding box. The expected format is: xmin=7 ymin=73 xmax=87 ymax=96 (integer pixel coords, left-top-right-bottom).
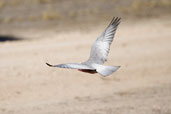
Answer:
xmin=0 ymin=18 xmax=171 ymax=114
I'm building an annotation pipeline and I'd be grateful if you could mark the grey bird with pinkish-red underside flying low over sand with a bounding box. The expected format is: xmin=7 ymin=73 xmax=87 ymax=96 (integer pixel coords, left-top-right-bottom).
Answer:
xmin=46 ymin=17 xmax=121 ymax=77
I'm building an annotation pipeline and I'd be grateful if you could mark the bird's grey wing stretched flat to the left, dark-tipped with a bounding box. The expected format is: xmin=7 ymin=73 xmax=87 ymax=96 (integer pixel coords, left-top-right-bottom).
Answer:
xmin=46 ymin=63 xmax=95 ymax=70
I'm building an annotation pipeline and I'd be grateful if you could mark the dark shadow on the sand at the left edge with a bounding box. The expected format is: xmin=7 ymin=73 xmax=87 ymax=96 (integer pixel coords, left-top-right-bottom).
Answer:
xmin=0 ymin=35 xmax=23 ymax=42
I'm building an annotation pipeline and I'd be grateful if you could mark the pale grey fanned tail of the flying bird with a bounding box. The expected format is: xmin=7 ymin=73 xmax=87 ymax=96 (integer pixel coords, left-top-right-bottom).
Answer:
xmin=93 ymin=64 xmax=120 ymax=77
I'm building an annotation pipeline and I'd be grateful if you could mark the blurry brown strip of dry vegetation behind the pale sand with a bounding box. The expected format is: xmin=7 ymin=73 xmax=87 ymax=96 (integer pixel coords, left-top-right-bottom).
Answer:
xmin=0 ymin=0 xmax=171 ymax=26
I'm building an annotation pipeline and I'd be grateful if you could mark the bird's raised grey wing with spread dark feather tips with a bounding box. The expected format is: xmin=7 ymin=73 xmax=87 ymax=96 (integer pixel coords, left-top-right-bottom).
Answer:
xmin=87 ymin=17 xmax=121 ymax=64
